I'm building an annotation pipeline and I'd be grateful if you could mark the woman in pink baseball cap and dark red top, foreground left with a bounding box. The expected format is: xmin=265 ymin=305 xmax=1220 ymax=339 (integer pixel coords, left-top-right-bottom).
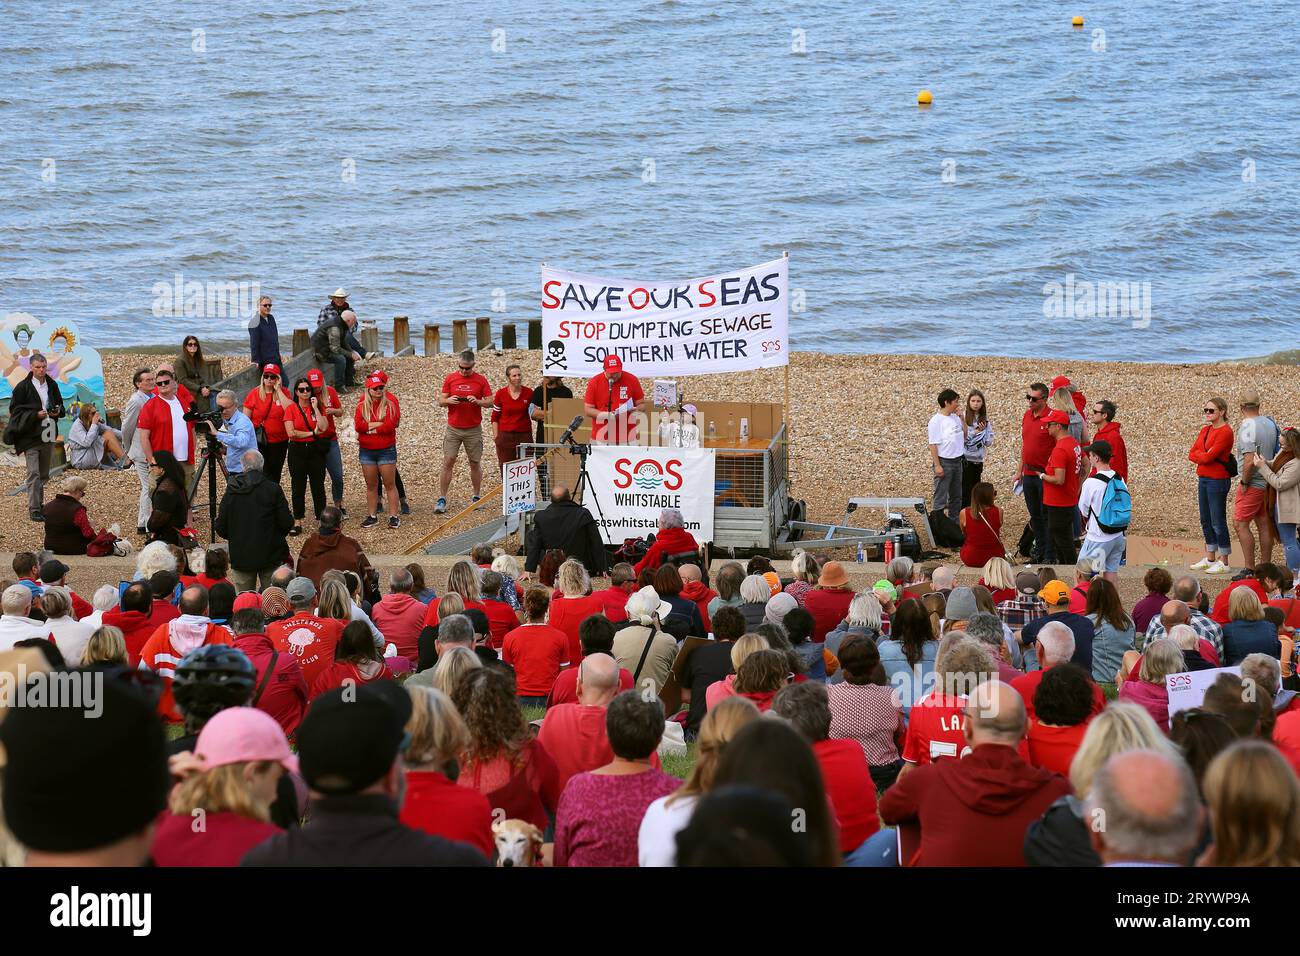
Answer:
xmin=152 ymin=708 xmax=298 ymax=866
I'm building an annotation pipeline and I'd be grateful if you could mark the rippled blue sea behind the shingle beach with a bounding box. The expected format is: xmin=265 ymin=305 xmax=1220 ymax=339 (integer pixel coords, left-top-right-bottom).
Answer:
xmin=0 ymin=0 xmax=1300 ymax=360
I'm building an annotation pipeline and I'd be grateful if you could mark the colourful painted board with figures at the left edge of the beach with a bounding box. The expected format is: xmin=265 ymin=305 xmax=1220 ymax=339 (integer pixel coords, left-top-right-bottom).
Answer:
xmin=0 ymin=312 xmax=105 ymax=438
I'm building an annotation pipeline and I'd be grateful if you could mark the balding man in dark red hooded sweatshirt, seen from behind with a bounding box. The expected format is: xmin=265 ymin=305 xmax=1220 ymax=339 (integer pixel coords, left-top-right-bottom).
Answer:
xmin=880 ymin=680 xmax=1070 ymax=866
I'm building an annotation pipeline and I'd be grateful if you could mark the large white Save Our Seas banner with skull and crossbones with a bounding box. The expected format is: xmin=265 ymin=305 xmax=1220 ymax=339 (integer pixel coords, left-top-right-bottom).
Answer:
xmin=542 ymin=258 xmax=790 ymax=376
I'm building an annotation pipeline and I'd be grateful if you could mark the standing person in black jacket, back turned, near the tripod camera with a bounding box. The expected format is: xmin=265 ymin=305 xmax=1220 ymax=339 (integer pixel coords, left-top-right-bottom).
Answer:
xmin=213 ymin=449 xmax=294 ymax=591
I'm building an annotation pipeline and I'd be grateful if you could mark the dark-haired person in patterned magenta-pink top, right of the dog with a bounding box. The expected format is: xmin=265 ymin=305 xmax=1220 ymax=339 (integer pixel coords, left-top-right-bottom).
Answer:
xmin=555 ymin=691 xmax=679 ymax=866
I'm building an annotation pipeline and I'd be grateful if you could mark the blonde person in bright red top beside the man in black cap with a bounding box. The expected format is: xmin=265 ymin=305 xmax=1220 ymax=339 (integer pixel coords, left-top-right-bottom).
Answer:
xmin=400 ymin=686 xmax=494 ymax=860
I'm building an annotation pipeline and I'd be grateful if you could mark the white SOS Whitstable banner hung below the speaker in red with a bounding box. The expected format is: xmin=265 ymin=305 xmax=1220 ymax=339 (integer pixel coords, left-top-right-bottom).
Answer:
xmin=582 ymin=445 xmax=715 ymax=545
